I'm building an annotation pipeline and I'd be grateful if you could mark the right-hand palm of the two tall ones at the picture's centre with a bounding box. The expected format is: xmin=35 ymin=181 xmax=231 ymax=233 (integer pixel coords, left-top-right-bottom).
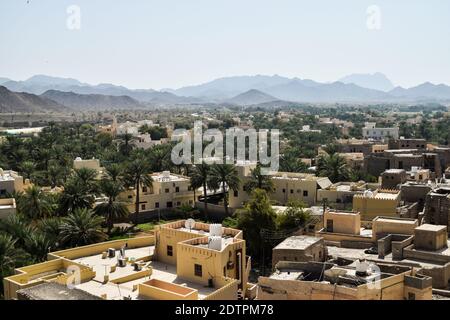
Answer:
xmin=210 ymin=164 xmax=240 ymax=215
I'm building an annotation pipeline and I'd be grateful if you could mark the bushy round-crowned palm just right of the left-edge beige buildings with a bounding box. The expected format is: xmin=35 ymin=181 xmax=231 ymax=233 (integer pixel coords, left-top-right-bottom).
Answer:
xmin=17 ymin=185 xmax=53 ymax=220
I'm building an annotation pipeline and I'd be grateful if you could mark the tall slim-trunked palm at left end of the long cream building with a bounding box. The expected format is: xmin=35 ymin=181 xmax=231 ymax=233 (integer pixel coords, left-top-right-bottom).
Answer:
xmin=125 ymin=157 xmax=153 ymax=223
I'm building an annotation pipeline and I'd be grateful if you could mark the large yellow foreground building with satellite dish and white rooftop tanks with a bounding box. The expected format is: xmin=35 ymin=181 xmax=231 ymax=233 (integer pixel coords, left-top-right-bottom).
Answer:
xmin=4 ymin=220 xmax=256 ymax=300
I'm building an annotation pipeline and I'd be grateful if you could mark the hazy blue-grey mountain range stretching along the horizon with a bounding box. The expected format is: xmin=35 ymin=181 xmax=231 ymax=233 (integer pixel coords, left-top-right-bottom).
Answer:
xmin=0 ymin=73 xmax=450 ymax=111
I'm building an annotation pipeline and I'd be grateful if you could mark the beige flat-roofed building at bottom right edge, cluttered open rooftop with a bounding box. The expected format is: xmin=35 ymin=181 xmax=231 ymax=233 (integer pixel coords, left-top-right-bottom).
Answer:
xmin=257 ymin=260 xmax=432 ymax=300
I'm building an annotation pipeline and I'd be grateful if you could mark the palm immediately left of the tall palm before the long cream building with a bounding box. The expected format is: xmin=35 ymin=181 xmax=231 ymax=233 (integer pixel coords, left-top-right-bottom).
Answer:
xmin=94 ymin=180 xmax=130 ymax=234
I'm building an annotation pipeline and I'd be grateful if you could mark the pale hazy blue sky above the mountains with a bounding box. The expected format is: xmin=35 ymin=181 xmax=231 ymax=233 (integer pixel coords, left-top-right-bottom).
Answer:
xmin=0 ymin=0 xmax=450 ymax=89
